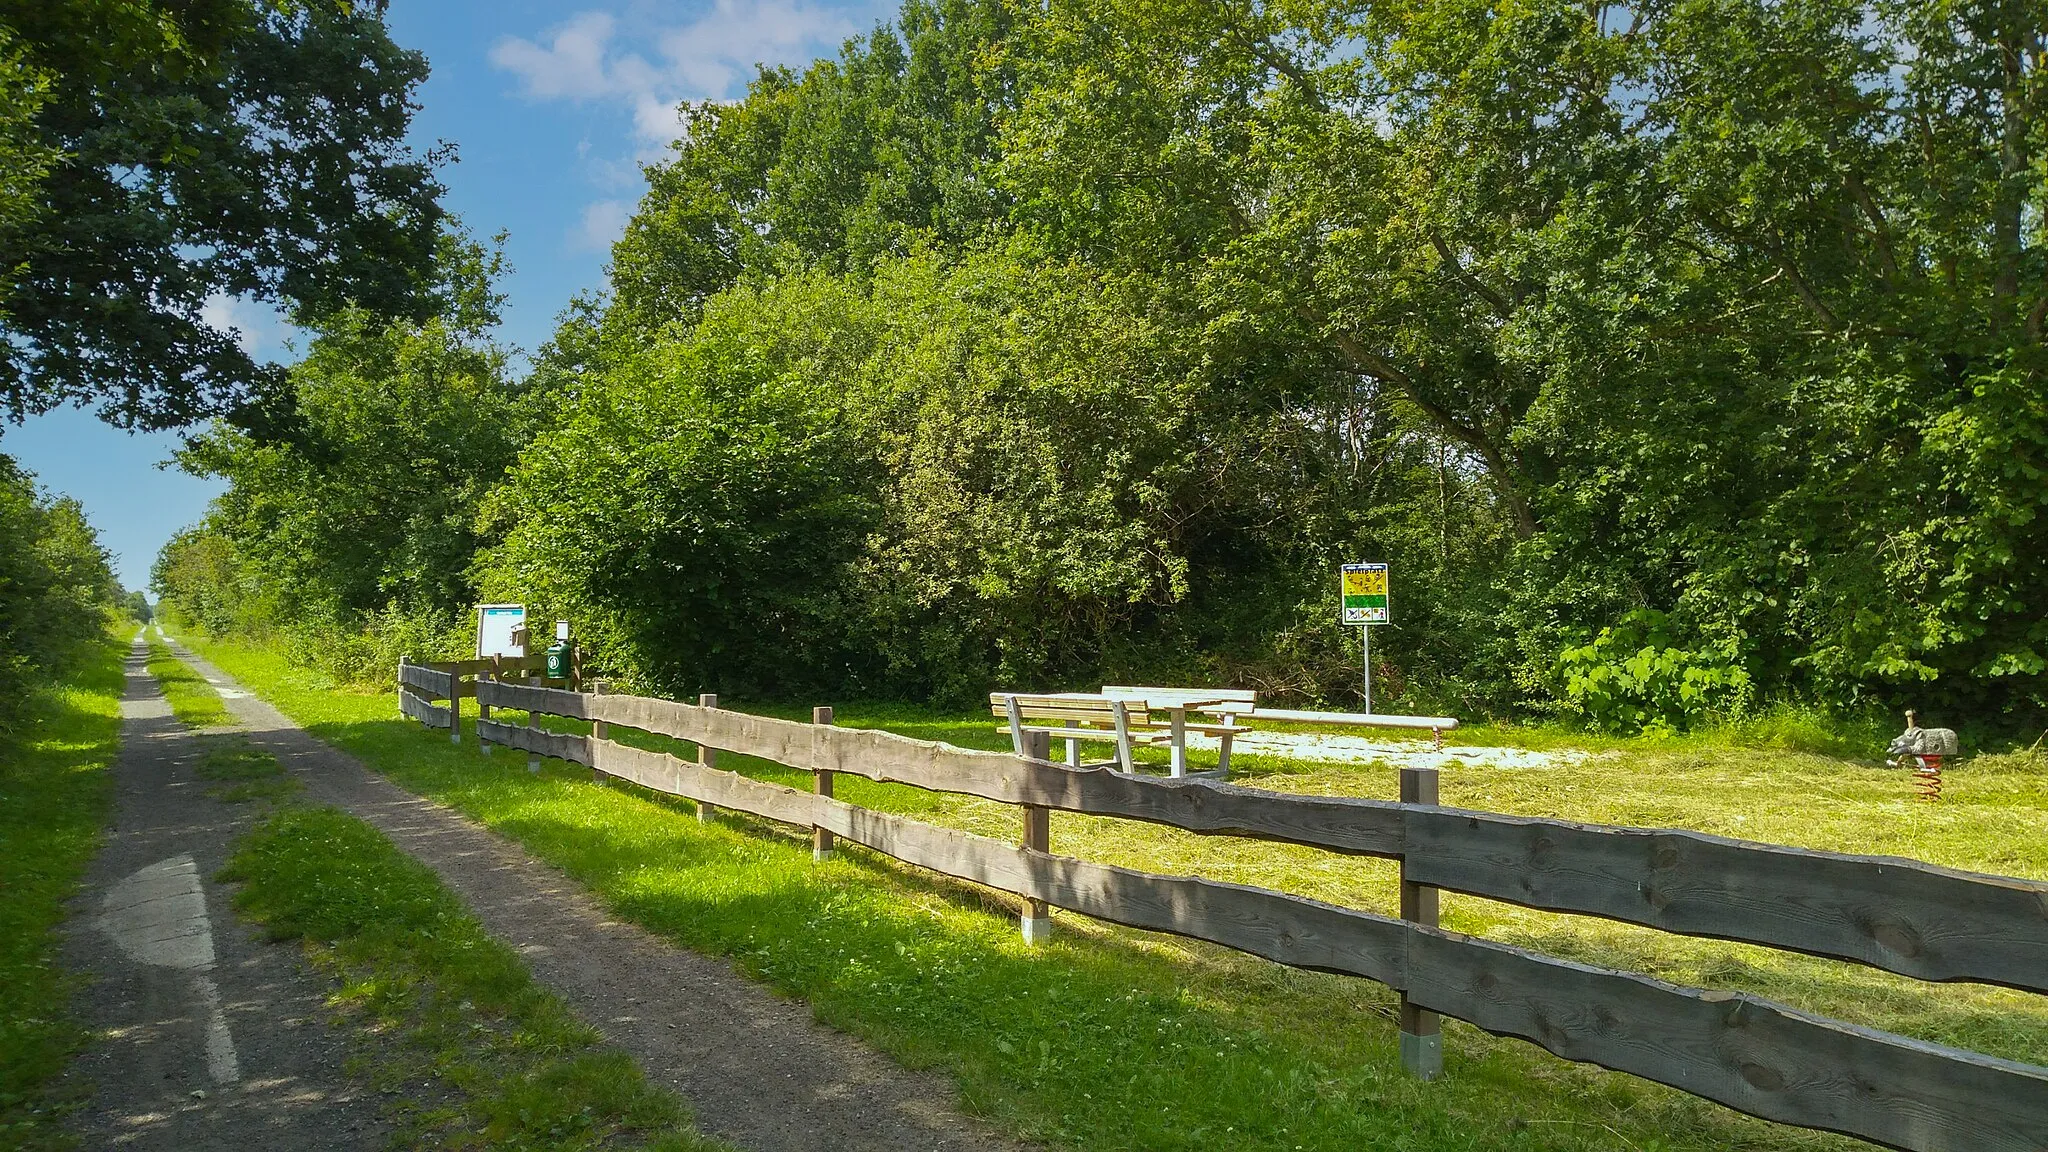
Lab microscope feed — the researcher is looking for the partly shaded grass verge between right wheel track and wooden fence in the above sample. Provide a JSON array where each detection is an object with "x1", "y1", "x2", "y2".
[{"x1": 272, "y1": 705, "x2": 1884, "y2": 1150}]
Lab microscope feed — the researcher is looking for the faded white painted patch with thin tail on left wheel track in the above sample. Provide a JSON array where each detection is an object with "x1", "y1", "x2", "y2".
[{"x1": 98, "y1": 855, "x2": 242, "y2": 1084}]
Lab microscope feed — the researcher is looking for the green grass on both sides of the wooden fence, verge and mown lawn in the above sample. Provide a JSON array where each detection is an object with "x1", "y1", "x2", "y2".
[{"x1": 188, "y1": 644, "x2": 2048, "y2": 1152}]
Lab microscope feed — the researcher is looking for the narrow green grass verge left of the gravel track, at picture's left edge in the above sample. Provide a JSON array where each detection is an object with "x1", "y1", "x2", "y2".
[{"x1": 0, "y1": 629, "x2": 127, "y2": 1150}]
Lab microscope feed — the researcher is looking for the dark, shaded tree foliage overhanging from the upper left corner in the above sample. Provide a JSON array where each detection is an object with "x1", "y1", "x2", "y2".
[{"x1": 0, "y1": 0, "x2": 440, "y2": 428}]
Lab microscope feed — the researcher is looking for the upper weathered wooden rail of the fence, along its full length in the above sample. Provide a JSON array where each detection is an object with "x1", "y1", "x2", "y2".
[{"x1": 479, "y1": 685, "x2": 2048, "y2": 992}]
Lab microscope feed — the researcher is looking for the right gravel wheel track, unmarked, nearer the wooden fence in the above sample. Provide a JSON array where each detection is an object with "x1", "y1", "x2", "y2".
[{"x1": 174, "y1": 635, "x2": 1016, "y2": 1152}]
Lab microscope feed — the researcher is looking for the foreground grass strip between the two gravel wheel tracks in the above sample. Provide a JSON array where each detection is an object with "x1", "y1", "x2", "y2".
[{"x1": 221, "y1": 799, "x2": 719, "y2": 1152}]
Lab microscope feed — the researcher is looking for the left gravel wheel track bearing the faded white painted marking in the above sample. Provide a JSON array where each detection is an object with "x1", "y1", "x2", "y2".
[{"x1": 61, "y1": 642, "x2": 387, "y2": 1152}]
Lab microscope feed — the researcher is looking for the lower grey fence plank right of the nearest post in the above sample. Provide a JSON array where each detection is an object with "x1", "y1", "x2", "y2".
[{"x1": 1407, "y1": 927, "x2": 2048, "y2": 1152}]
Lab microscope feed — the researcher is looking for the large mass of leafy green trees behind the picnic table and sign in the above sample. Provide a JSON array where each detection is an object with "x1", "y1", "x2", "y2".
[{"x1": 155, "y1": 0, "x2": 2048, "y2": 726}]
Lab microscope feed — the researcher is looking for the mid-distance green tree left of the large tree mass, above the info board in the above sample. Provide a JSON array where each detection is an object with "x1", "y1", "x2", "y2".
[{"x1": 174, "y1": 236, "x2": 524, "y2": 625}]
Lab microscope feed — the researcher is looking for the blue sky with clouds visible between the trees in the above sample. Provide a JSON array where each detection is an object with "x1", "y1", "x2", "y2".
[{"x1": 0, "y1": 0, "x2": 893, "y2": 588}]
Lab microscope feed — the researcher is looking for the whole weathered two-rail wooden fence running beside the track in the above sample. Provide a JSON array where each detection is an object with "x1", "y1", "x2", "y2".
[{"x1": 399, "y1": 666, "x2": 2048, "y2": 1152}]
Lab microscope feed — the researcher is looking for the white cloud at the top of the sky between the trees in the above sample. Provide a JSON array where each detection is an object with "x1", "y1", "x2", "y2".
[{"x1": 492, "y1": 0, "x2": 856, "y2": 147}]
